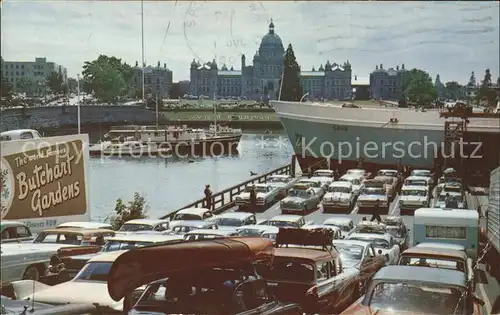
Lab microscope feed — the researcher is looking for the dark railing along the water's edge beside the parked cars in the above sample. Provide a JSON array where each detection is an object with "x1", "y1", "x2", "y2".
[{"x1": 160, "y1": 157, "x2": 295, "y2": 219}]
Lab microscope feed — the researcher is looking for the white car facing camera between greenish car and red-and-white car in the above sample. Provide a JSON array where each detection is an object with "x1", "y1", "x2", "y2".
[{"x1": 322, "y1": 181, "x2": 355, "y2": 212}]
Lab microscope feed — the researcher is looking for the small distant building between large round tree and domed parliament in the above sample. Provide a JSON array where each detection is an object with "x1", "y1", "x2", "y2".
[{"x1": 133, "y1": 61, "x2": 172, "y2": 98}]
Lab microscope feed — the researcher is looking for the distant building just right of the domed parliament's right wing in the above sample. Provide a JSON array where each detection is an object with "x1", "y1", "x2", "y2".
[{"x1": 370, "y1": 64, "x2": 406, "y2": 101}]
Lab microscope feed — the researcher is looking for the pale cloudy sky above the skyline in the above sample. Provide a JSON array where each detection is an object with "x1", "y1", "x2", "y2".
[{"x1": 1, "y1": 0, "x2": 500, "y2": 83}]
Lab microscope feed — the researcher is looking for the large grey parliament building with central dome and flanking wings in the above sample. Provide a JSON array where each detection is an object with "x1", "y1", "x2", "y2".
[{"x1": 189, "y1": 21, "x2": 352, "y2": 99}]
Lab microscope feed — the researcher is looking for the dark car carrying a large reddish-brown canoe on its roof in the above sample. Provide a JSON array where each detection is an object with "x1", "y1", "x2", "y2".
[{"x1": 108, "y1": 237, "x2": 301, "y2": 315}]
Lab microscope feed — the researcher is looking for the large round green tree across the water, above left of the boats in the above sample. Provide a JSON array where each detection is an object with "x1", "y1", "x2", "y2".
[{"x1": 82, "y1": 55, "x2": 135, "y2": 103}]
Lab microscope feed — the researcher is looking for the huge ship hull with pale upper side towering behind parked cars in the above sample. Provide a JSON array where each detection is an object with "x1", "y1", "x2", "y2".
[{"x1": 271, "y1": 101, "x2": 500, "y2": 175}]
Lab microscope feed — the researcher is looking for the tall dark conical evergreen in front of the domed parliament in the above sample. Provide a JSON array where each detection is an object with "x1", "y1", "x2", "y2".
[{"x1": 277, "y1": 44, "x2": 302, "y2": 102}]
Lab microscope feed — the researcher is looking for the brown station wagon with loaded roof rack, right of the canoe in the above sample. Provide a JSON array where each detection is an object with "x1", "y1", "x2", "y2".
[{"x1": 258, "y1": 229, "x2": 359, "y2": 314}]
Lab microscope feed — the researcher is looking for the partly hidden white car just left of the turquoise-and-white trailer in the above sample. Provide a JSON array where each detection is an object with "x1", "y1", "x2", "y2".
[{"x1": 347, "y1": 233, "x2": 400, "y2": 265}]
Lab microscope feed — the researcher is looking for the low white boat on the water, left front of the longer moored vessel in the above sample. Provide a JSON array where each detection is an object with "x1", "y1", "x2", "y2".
[{"x1": 89, "y1": 140, "x2": 172, "y2": 157}]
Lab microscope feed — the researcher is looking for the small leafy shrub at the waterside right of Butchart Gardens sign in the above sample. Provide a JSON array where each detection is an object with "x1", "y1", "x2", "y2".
[{"x1": 106, "y1": 192, "x2": 148, "y2": 230}]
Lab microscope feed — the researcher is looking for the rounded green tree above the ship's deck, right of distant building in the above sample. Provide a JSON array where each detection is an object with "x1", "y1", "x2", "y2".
[{"x1": 401, "y1": 69, "x2": 437, "y2": 105}]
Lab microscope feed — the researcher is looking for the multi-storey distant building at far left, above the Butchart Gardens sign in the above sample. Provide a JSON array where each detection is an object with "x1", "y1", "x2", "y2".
[{"x1": 1, "y1": 57, "x2": 68, "y2": 94}]
